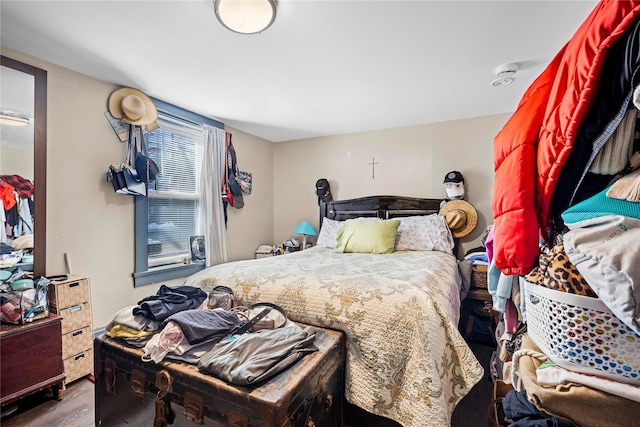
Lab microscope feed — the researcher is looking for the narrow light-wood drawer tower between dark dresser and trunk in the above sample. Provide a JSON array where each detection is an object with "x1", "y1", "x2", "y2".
[{"x1": 49, "y1": 274, "x2": 93, "y2": 383}]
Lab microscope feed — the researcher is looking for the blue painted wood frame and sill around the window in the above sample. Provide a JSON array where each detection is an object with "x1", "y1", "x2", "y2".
[{"x1": 132, "y1": 97, "x2": 224, "y2": 287}]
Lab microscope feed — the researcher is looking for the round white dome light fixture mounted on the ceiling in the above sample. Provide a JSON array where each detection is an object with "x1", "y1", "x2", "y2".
[{"x1": 213, "y1": 0, "x2": 278, "y2": 34}]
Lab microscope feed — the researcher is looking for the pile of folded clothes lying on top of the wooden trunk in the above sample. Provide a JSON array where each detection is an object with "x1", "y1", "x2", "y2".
[{"x1": 106, "y1": 285, "x2": 318, "y2": 385}]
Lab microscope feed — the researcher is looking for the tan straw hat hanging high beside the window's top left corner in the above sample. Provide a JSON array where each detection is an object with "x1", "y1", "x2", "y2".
[{"x1": 109, "y1": 87, "x2": 158, "y2": 125}]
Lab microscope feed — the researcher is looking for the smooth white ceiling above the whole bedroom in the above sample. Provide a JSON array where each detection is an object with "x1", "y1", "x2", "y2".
[{"x1": 0, "y1": 0, "x2": 597, "y2": 142}]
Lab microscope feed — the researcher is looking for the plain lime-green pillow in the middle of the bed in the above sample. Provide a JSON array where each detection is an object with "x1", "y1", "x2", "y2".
[{"x1": 336, "y1": 219, "x2": 400, "y2": 254}]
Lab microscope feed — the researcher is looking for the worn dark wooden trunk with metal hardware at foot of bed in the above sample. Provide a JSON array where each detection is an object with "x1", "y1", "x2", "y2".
[{"x1": 94, "y1": 328, "x2": 345, "y2": 427}]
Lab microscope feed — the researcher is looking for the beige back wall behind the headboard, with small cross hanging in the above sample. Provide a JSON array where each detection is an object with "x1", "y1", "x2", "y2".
[{"x1": 273, "y1": 114, "x2": 509, "y2": 260}]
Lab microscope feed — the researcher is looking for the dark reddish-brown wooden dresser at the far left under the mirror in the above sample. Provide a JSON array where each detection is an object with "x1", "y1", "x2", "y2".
[{"x1": 0, "y1": 315, "x2": 65, "y2": 405}]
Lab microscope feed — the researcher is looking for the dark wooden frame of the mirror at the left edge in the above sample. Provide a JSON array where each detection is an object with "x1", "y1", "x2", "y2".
[{"x1": 0, "y1": 55, "x2": 47, "y2": 277}]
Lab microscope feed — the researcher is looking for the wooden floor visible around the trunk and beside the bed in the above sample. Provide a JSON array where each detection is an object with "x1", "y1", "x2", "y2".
[{"x1": 0, "y1": 343, "x2": 492, "y2": 427}]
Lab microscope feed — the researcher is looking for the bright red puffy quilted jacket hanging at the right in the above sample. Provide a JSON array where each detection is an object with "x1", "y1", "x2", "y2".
[{"x1": 492, "y1": 0, "x2": 640, "y2": 275}]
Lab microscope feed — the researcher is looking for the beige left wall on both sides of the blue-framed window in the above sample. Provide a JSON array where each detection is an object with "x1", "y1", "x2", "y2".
[{"x1": 2, "y1": 48, "x2": 273, "y2": 328}]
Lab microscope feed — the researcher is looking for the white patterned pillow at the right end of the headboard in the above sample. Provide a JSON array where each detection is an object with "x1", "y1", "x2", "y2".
[{"x1": 396, "y1": 214, "x2": 454, "y2": 253}]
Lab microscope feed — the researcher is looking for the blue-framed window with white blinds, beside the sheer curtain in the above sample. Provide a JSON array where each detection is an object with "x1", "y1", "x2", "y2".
[{"x1": 133, "y1": 99, "x2": 224, "y2": 286}]
